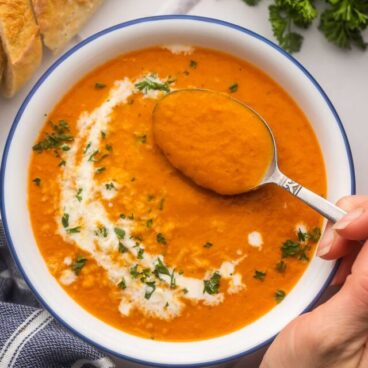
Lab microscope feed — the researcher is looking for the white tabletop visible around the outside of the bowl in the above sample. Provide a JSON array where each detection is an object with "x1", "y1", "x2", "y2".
[{"x1": 0, "y1": 0, "x2": 368, "y2": 368}]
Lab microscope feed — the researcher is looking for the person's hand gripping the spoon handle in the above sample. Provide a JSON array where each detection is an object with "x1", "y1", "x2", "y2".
[{"x1": 261, "y1": 196, "x2": 368, "y2": 368}]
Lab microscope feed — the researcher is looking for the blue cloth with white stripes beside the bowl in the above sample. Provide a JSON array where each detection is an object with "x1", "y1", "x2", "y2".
[{"x1": 0, "y1": 221, "x2": 115, "y2": 368}]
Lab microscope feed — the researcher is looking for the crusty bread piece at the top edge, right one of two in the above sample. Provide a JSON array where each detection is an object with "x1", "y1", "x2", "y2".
[{"x1": 32, "y1": 0, "x2": 103, "y2": 52}]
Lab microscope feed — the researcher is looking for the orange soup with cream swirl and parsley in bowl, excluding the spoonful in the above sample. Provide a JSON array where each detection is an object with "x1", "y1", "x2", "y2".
[{"x1": 29, "y1": 47, "x2": 326, "y2": 341}]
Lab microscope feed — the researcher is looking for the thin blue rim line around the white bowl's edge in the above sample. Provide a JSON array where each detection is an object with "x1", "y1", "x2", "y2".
[{"x1": 0, "y1": 15, "x2": 356, "y2": 368}]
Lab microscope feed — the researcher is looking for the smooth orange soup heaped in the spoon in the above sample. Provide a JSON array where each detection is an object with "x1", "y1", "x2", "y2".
[{"x1": 153, "y1": 89, "x2": 273, "y2": 195}]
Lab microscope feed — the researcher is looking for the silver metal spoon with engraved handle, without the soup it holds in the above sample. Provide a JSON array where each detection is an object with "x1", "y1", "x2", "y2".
[{"x1": 153, "y1": 89, "x2": 346, "y2": 223}]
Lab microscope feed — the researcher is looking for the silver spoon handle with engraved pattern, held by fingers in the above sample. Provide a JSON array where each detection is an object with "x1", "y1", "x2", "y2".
[{"x1": 275, "y1": 173, "x2": 346, "y2": 223}]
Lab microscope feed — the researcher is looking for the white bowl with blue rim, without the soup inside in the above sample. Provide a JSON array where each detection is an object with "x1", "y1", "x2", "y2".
[{"x1": 1, "y1": 16, "x2": 355, "y2": 367}]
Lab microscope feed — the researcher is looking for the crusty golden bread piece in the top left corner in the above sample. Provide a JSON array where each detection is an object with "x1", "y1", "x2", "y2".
[{"x1": 0, "y1": 0, "x2": 42, "y2": 97}]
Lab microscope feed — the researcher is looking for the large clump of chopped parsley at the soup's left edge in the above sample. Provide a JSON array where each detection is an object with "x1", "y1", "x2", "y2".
[{"x1": 32, "y1": 120, "x2": 74, "y2": 153}]
